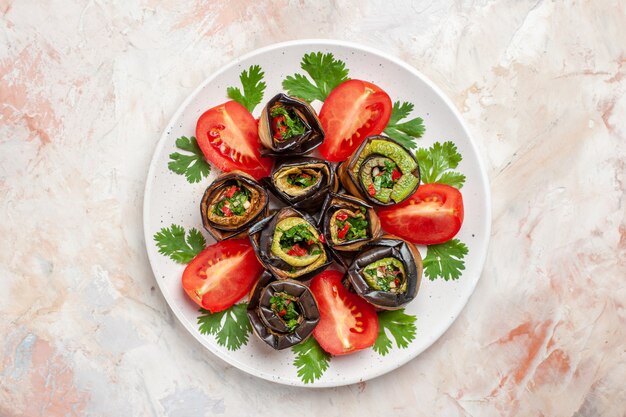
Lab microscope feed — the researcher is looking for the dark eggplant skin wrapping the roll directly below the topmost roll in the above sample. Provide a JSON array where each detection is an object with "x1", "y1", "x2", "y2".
[{"x1": 261, "y1": 156, "x2": 339, "y2": 213}]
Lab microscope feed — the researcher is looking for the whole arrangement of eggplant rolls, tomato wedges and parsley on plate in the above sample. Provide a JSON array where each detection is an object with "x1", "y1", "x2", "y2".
[{"x1": 154, "y1": 52, "x2": 467, "y2": 383}]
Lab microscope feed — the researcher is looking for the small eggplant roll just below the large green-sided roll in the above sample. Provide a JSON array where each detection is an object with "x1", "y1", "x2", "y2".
[{"x1": 320, "y1": 193, "x2": 382, "y2": 252}]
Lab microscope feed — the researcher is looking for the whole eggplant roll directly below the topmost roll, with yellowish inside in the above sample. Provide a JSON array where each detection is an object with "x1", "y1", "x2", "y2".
[{"x1": 263, "y1": 157, "x2": 339, "y2": 211}]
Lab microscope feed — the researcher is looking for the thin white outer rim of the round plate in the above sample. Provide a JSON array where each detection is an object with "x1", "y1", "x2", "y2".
[{"x1": 142, "y1": 38, "x2": 492, "y2": 388}]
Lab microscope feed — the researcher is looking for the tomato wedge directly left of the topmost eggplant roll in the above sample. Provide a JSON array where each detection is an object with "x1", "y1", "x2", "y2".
[{"x1": 196, "y1": 101, "x2": 272, "y2": 180}]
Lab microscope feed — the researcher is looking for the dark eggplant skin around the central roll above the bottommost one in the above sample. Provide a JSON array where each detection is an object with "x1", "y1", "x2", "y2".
[{"x1": 248, "y1": 207, "x2": 333, "y2": 281}]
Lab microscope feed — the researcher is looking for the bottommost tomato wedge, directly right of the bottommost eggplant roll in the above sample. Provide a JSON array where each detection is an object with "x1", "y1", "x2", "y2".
[{"x1": 310, "y1": 271, "x2": 378, "y2": 355}]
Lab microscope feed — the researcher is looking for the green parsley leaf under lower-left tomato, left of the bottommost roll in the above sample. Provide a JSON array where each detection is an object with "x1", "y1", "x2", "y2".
[{"x1": 198, "y1": 303, "x2": 252, "y2": 350}]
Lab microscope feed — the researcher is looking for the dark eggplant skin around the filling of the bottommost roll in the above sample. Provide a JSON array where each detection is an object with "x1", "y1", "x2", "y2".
[{"x1": 247, "y1": 271, "x2": 320, "y2": 350}]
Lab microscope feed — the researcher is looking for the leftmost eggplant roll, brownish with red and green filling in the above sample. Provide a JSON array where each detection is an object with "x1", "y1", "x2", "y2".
[{"x1": 200, "y1": 172, "x2": 269, "y2": 240}]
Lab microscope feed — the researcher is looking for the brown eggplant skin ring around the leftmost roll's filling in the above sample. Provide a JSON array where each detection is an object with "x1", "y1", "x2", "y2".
[{"x1": 200, "y1": 171, "x2": 269, "y2": 241}]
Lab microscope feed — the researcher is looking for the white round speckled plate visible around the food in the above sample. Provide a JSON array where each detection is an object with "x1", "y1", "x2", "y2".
[{"x1": 144, "y1": 40, "x2": 491, "y2": 387}]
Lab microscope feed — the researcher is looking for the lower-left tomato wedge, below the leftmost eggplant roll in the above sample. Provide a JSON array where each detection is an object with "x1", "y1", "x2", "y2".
[{"x1": 183, "y1": 239, "x2": 263, "y2": 313}]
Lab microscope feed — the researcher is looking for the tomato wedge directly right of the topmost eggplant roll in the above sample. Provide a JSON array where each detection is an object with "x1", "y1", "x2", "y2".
[{"x1": 318, "y1": 80, "x2": 391, "y2": 162}]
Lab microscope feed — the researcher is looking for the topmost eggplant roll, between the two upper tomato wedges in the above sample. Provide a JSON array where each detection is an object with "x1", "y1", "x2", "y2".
[{"x1": 259, "y1": 94, "x2": 324, "y2": 156}]
